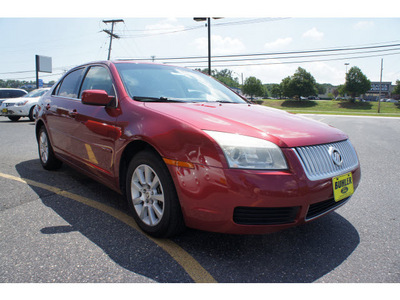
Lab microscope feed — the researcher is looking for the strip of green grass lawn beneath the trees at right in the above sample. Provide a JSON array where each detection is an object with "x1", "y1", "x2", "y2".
[{"x1": 262, "y1": 99, "x2": 400, "y2": 117}]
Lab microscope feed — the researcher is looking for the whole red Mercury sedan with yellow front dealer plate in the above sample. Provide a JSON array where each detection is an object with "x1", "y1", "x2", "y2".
[{"x1": 36, "y1": 61, "x2": 361, "y2": 237}]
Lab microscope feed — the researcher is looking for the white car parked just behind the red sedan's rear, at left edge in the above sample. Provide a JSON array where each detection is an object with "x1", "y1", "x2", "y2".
[{"x1": 0, "y1": 88, "x2": 50, "y2": 122}]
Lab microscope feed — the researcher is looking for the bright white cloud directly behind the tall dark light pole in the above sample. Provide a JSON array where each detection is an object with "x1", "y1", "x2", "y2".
[{"x1": 194, "y1": 35, "x2": 246, "y2": 55}]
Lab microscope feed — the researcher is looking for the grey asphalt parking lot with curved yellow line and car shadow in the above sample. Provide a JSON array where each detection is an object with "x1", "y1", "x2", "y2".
[{"x1": 0, "y1": 115, "x2": 400, "y2": 283}]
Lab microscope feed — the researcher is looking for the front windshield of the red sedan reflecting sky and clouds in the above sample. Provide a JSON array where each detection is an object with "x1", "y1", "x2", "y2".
[{"x1": 116, "y1": 63, "x2": 246, "y2": 103}]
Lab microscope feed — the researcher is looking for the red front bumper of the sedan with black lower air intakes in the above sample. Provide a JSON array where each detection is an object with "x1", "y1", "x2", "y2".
[{"x1": 168, "y1": 150, "x2": 361, "y2": 234}]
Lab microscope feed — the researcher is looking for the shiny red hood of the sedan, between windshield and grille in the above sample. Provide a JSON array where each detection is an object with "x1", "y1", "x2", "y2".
[{"x1": 145, "y1": 102, "x2": 348, "y2": 147}]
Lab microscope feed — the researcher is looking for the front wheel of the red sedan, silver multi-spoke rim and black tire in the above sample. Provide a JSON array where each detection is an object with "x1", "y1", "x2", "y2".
[{"x1": 126, "y1": 151, "x2": 184, "y2": 237}]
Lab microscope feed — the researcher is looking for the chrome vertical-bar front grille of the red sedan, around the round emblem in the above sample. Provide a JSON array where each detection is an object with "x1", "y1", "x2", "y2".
[{"x1": 295, "y1": 140, "x2": 358, "y2": 180}]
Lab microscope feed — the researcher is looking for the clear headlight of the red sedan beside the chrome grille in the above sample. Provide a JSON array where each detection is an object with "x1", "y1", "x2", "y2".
[{"x1": 204, "y1": 130, "x2": 288, "y2": 170}]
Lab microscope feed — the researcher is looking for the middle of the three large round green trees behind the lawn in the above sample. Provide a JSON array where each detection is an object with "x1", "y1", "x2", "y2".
[{"x1": 281, "y1": 67, "x2": 318, "y2": 97}]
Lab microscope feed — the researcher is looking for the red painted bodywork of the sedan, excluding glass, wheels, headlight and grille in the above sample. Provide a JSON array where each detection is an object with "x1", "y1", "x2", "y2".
[{"x1": 36, "y1": 62, "x2": 361, "y2": 234}]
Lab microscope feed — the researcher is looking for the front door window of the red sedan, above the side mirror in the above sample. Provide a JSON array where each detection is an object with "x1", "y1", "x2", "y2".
[{"x1": 81, "y1": 66, "x2": 115, "y2": 96}]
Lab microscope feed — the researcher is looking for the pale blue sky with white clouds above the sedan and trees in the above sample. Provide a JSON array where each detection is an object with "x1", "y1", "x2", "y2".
[{"x1": 0, "y1": 0, "x2": 400, "y2": 85}]
